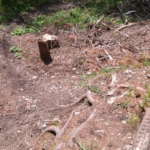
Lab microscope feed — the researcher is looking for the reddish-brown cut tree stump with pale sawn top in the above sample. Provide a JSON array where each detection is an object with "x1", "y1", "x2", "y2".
[{"x1": 38, "y1": 34, "x2": 59, "y2": 64}]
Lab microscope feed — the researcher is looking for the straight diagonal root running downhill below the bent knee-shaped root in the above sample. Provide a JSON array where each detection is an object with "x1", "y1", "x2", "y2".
[{"x1": 67, "y1": 109, "x2": 97, "y2": 147}]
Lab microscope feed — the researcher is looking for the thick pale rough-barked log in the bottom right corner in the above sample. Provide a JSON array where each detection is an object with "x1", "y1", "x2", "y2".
[{"x1": 133, "y1": 108, "x2": 150, "y2": 150}]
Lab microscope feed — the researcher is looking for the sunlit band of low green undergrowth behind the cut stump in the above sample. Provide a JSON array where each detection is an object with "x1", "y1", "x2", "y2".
[{"x1": 11, "y1": 8, "x2": 98, "y2": 36}]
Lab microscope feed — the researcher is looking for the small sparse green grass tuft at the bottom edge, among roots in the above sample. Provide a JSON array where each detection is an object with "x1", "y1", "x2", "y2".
[{"x1": 77, "y1": 140, "x2": 97, "y2": 150}]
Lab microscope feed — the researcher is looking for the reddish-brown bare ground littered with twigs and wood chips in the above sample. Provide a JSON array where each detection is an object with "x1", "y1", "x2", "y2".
[{"x1": 0, "y1": 1, "x2": 150, "y2": 150}]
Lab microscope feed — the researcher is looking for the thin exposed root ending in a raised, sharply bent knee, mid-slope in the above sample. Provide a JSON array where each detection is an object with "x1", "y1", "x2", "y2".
[{"x1": 57, "y1": 91, "x2": 95, "y2": 108}]
